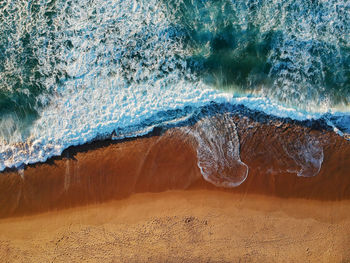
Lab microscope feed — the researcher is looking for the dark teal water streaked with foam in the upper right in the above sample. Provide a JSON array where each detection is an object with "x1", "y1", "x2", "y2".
[{"x1": 165, "y1": 0, "x2": 350, "y2": 108}]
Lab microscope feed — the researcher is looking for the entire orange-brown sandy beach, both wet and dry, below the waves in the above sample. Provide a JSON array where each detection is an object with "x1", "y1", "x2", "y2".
[{"x1": 0, "y1": 117, "x2": 350, "y2": 262}]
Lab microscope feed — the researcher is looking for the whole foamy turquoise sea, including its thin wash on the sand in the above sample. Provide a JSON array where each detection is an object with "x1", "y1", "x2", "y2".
[{"x1": 0, "y1": 0, "x2": 350, "y2": 175}]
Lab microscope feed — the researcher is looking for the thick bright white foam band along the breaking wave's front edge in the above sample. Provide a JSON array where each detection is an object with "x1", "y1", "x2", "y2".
[{"x1": 0, "y1": 75, "x2": 344, "y2": 172}]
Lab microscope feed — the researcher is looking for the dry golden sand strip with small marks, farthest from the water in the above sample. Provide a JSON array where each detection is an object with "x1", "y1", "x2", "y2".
[{"x1": 0, "y1": 190, "x2": 350, "y2": 262}]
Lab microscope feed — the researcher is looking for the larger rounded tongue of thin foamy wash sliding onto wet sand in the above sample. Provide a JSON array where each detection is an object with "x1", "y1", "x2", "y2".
[{"x1": 180, "y1": 114, "x2": 249, "y2": 187}]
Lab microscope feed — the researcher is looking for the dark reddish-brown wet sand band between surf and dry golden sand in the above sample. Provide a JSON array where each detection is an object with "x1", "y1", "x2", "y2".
[{"x1": 0, "y1": 115, "x2": 350, "y2": 218}]
